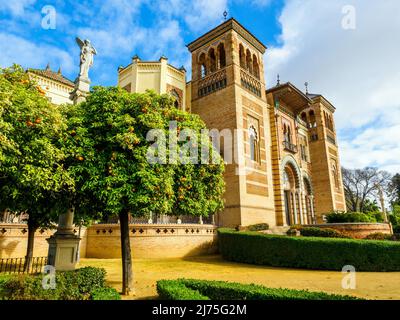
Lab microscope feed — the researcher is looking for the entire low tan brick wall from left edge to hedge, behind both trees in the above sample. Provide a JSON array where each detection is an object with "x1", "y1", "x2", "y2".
[{"x1": 0, "y1": 224, "x2": 217, "y2": 259}]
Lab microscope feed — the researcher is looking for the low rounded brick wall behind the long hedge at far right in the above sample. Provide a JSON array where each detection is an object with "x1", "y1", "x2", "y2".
[{"x1": 312, "y1": 222, "x2": 393, "y2": 239}]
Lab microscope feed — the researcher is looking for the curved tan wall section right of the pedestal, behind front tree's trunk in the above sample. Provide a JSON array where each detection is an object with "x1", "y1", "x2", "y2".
[{"x1": 86, "y1": 224, "x2": 217, "y2": 259}]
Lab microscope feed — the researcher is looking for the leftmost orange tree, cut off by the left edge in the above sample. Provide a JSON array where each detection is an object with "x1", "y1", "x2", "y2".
[{"x1": 0, "y1": 65, "x2": 74, "y2": 268}]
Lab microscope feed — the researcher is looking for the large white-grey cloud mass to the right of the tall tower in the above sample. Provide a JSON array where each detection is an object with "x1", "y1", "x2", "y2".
[{"x1": 266, "y1": 0, "x2": 400, "y2": 171}]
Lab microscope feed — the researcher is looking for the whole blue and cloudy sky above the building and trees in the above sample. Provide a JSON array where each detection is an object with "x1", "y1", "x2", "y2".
[{"x1": 0, "y1": 0, "x2": 400, "y2": 173}]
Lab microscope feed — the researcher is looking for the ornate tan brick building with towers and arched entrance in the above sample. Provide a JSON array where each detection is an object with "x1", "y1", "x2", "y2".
[{"x1": 119, "y1": 18, "x2": 346, "y2": 226}]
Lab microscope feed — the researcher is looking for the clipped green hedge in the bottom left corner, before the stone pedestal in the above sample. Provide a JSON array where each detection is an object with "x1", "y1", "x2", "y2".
[{"x1": 0, "y1": 267, "x2": 120, "y2": 300}]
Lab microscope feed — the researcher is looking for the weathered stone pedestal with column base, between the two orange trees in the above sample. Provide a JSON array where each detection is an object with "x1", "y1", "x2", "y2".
[{"x1": 47, "y1": 208, "x2": 81, "y2": 271}]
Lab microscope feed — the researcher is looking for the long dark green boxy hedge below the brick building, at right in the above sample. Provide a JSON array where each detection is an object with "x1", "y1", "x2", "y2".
[{"x1": 218, "y1": 228, "x2": 400, "y2": 271}]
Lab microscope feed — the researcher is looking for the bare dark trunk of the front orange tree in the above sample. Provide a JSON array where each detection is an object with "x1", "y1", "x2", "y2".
[{"x1": 119, "y1": 211, "x2": 133, "y2": 295}]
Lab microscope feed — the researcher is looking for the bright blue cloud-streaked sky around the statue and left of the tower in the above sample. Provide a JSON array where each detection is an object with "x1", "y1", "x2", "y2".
[{"x1": 0, "y1": 0, "x2": 283, "y2": 85}]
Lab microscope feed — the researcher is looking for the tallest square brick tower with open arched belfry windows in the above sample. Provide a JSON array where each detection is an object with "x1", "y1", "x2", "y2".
[{"x1": 188, "y1": 18, "x2": 275, "y2": 226}]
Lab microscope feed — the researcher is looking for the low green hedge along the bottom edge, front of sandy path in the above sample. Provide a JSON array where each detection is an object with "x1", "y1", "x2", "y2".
[{"x1": 157, "y1": 279, "x2": 358, "y2": 300}]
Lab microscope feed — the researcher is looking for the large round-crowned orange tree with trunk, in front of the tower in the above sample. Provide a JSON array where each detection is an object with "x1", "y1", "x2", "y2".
[{"x1": 64, "y1": 87, "x2": 224, "y2": 294}]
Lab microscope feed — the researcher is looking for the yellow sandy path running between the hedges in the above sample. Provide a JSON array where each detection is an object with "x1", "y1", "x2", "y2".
[{"x1": 80, "y1": 255, "x2": 400, "y2": 300}]
